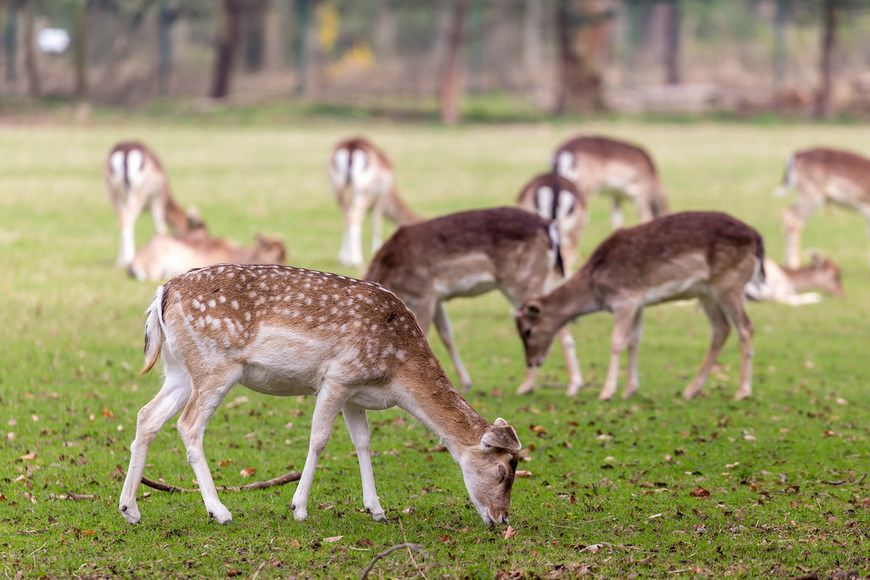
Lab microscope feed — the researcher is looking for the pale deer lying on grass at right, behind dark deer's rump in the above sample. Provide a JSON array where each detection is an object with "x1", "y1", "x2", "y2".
[{"x1": 746, "y1": 253, "x2": 844, "y2": 306}]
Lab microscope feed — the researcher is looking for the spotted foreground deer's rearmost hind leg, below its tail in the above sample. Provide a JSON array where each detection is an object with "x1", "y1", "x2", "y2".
[{"x1": 118, "y1": 350, "x2": 191, "y2": 524}]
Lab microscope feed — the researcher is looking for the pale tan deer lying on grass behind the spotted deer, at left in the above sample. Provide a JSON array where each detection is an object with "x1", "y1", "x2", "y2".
[{"x1": 129, "y1": 233, "x2": 287, "y2": 281}]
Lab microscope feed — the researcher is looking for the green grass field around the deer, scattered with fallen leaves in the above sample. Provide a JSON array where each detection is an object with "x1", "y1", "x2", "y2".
[{"x1": 0, "y1": 115, "x2": 870, "y2": 578}]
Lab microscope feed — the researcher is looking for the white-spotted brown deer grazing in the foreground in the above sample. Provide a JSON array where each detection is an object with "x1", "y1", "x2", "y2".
[{"x1": 119, "y1": 265, "x2": 521, "y2": 524}]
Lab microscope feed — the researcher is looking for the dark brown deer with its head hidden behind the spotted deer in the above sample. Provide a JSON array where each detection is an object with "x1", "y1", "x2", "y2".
[{"x1": 365, "y1": 207, "x2": 583, "y2": 395}]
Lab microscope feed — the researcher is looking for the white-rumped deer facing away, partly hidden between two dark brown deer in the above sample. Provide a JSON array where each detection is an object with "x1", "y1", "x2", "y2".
[{"x1": 517, "y1": 173, "x2": 589, "y2": 272}]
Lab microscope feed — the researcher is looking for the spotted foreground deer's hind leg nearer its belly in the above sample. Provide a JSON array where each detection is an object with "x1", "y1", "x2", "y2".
[{"x1": 178, "y1": 368, "x2": 239, "y2": 524}]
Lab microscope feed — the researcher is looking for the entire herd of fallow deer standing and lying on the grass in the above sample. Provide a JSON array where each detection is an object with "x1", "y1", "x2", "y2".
[{"x1": 103, "y1": 135, "x2": 870, "y2": 524}]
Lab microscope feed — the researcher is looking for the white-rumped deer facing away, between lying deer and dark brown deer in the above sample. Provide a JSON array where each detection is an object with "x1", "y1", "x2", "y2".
[{"x1": 329, "y1": 137, "x2": 419, "y2": 268}]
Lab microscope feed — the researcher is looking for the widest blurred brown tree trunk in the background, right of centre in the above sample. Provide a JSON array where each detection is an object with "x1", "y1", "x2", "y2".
[{"x1": 554, "y1": 0, "x2": 615, "y2": 115}]
